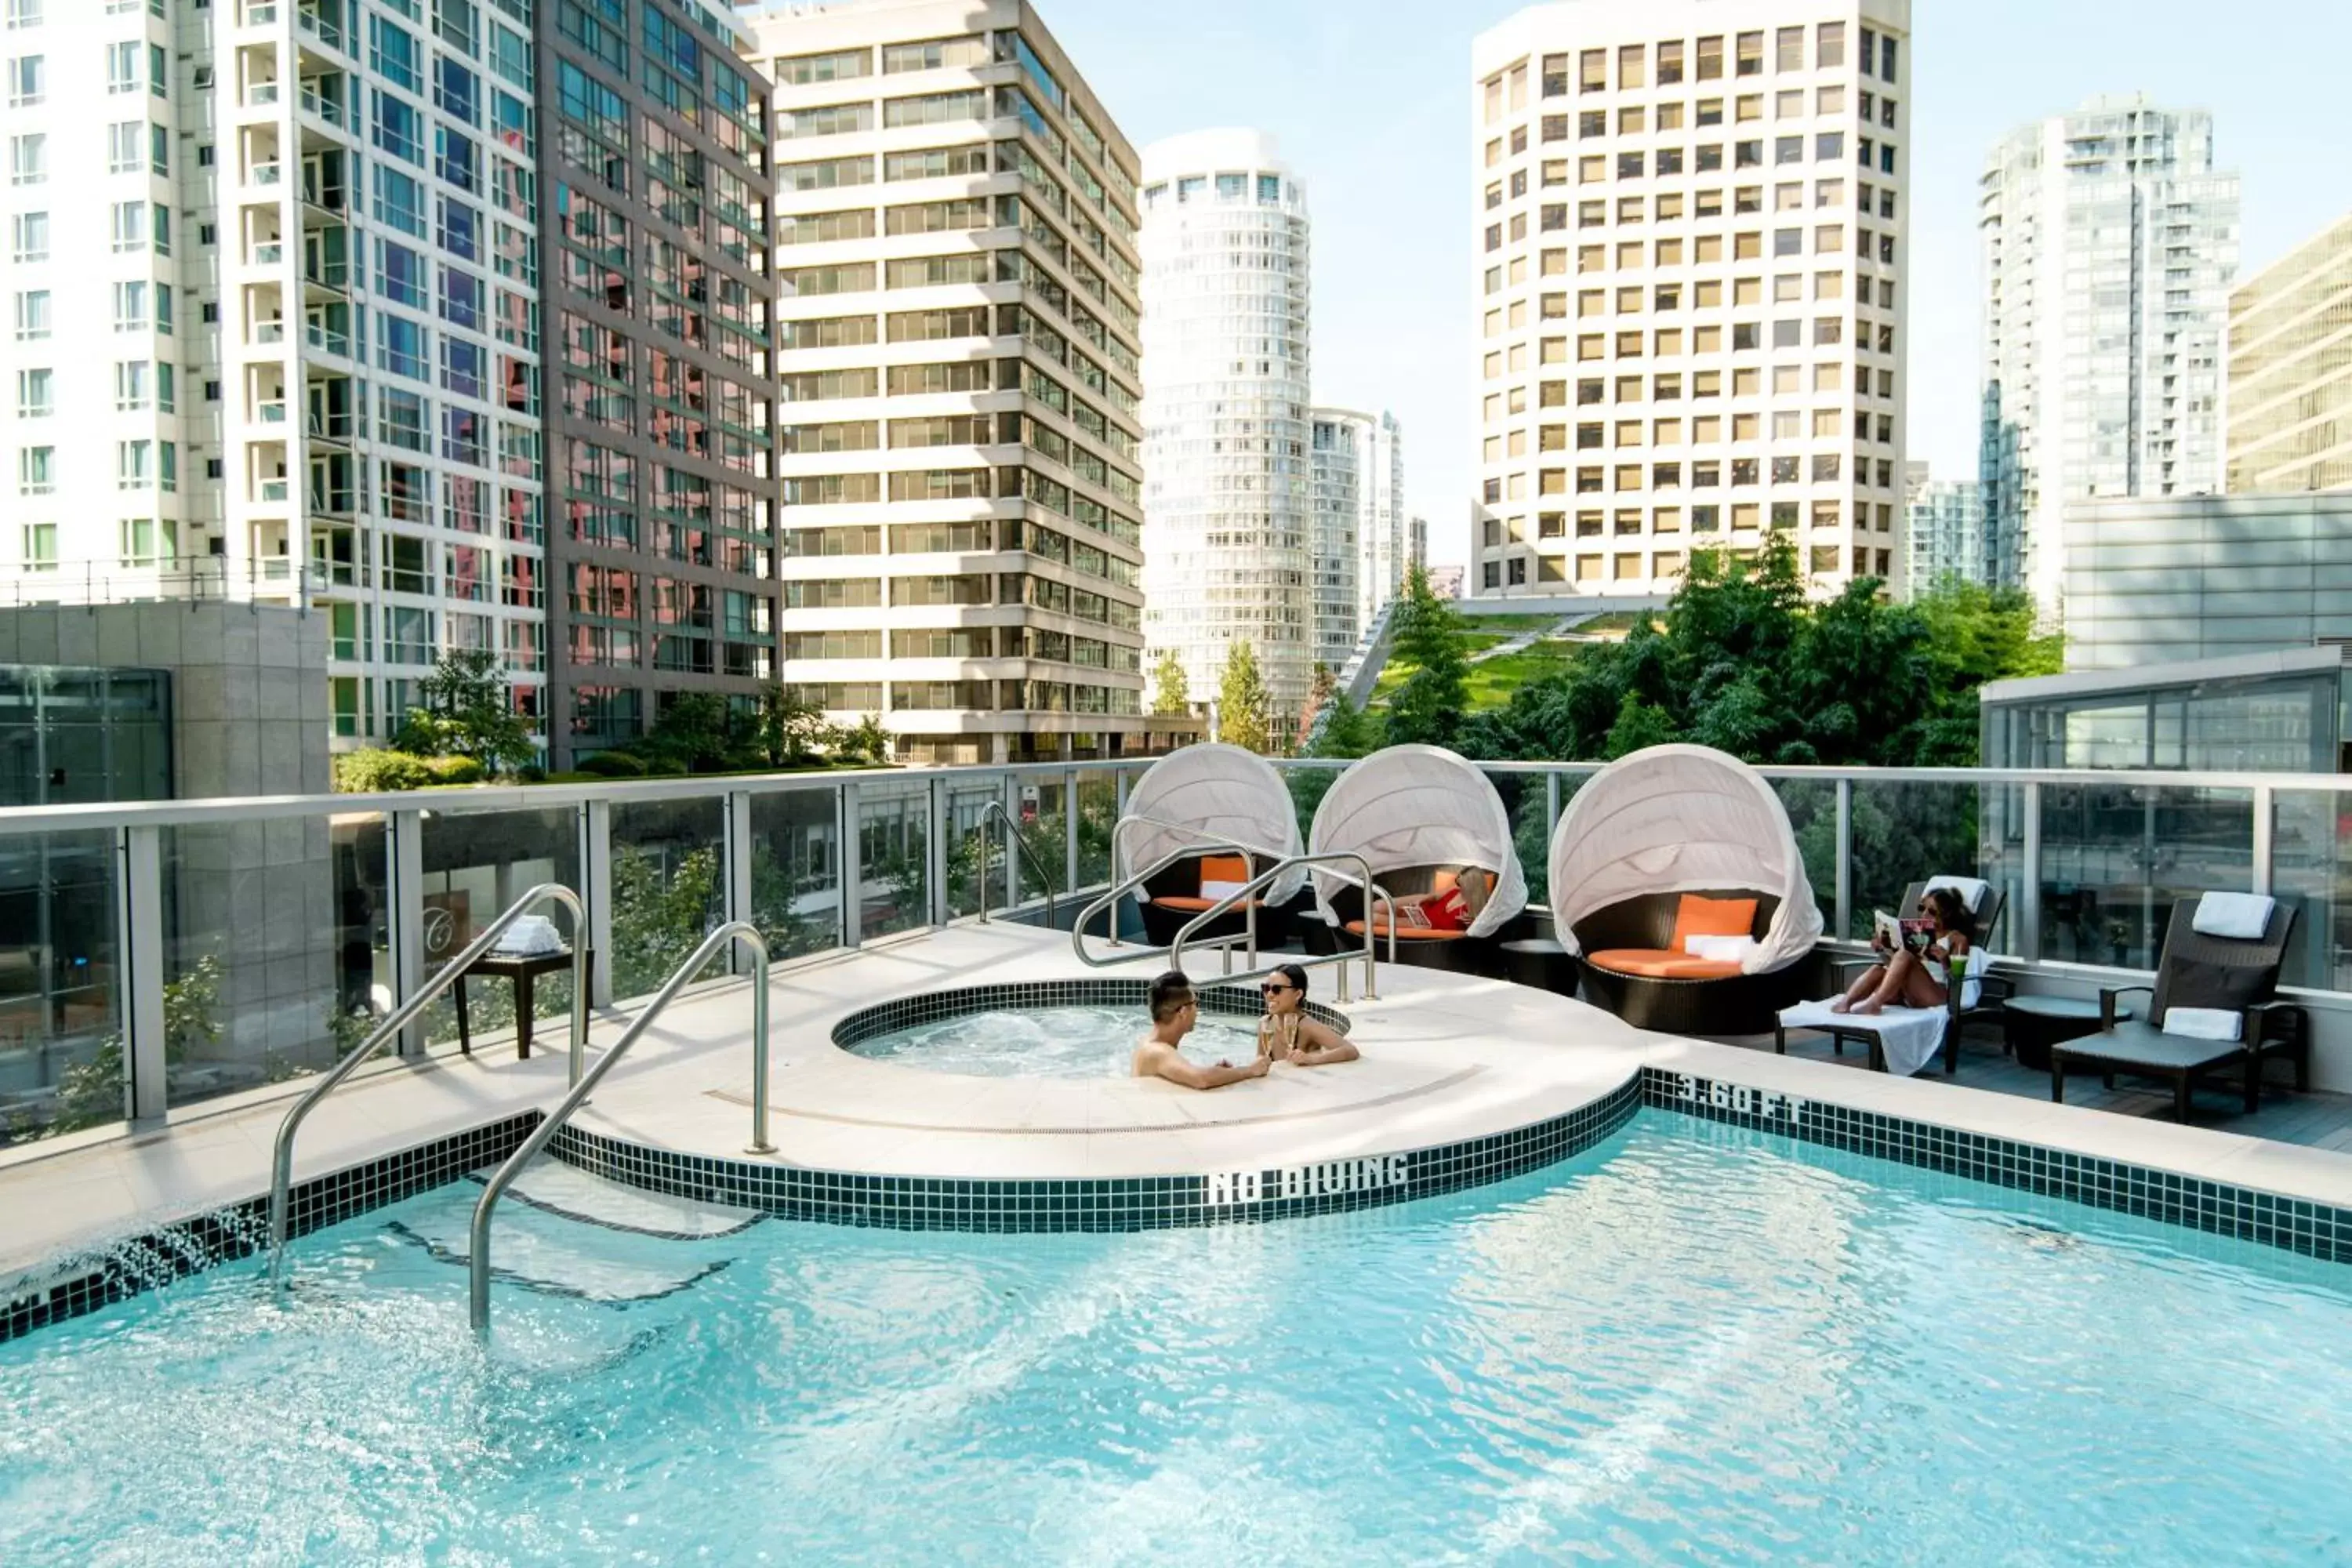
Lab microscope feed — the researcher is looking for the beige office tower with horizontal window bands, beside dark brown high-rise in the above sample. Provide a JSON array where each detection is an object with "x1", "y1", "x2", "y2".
[{"x1": 750, "y1": 0, "x2": 1152, "y2": 762}]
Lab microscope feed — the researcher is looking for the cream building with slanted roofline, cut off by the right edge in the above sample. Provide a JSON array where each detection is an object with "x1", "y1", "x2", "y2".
[{"x1": 2225, "y1": 216, "x2": 2352, "y2": 494}]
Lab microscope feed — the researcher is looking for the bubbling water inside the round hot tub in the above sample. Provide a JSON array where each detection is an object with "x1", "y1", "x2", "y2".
[{"x1": 844, "y1": 1006, "x2": 1258, "y2": 1079}]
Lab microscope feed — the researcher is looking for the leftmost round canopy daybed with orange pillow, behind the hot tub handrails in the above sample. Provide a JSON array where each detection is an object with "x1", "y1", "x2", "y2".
[{"x1": 1112, "y1": 741, "x2": 1305, "y2": 947}]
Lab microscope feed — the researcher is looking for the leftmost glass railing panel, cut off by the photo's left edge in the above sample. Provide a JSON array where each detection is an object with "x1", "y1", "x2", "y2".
[{"x1": 0, "y1": 829, "x2": 125, "y2": 1145}]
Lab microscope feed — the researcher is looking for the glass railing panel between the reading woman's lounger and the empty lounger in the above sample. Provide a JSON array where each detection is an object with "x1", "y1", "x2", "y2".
[{"x1": 2039, "y1": 783, "x2": 2253, "y2": 968}]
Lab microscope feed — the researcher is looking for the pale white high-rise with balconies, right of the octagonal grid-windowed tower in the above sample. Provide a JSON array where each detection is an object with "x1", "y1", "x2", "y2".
[{"x1": 1978, "y1": 96, "x2": 2237, "y2": 616}]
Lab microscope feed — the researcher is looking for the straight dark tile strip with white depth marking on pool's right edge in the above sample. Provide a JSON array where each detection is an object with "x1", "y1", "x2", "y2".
[{"x1": 1639, "y1": 1067, "x2": 2352, "y2": 1262}]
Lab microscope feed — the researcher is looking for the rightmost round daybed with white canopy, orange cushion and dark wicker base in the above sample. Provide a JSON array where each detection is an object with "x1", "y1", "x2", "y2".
[{"x1": 1550, "y1": 746, "x2": 1820, "y2": 1034}]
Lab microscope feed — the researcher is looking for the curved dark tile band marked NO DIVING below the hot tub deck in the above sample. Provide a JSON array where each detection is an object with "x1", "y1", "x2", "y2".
[{"x1": 550, "y1": 1079, "x2": 1642, "y2": 1232}]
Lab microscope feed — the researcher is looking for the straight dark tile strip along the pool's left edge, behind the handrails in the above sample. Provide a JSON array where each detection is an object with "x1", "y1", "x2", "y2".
[{"x1": 0, "y1": 1109, "x2": 539, "y2": 1340}]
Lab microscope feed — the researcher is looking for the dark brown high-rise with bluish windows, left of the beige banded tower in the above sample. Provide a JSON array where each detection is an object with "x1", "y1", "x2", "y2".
[{"x1": 541, "y1": 0, "x2": 779, "y2": 767}]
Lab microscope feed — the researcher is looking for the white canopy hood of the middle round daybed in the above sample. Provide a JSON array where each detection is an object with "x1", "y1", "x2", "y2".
[{"x1": 1308, "y1": 746, "x2": 1526, "y2": 935}]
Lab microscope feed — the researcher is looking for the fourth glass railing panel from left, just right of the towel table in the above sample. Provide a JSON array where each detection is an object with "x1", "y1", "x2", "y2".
[{"x1": 612, "y1": 794, "x2": 727, "y2": 1001}]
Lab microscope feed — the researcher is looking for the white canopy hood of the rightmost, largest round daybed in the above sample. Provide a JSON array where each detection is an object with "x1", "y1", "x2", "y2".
[{"x1": 1550, "y1": 746, "x2": 1820, "y2": 973}]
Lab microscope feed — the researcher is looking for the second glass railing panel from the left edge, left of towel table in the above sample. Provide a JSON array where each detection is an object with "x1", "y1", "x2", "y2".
[{"x1": 162, "y1": 811, "x2": 390, "y2": 1109}]
